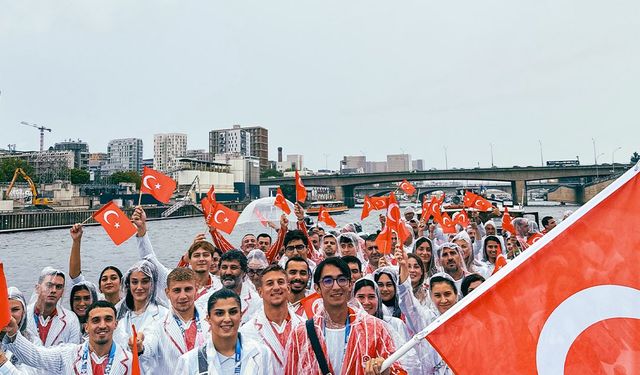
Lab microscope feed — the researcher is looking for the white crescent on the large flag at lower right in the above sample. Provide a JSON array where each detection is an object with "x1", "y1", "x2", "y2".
[{"x1": 536, "y1": 285, "x2": 640, "y2": 375}]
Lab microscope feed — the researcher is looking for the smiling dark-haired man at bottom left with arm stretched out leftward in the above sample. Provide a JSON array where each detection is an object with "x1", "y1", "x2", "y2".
[{"x1": 6, "y1": 301, "x2": 132, "y2": 375}]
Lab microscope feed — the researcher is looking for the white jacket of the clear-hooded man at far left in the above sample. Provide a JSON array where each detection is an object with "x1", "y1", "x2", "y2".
[{"x1": 27, "y1": 303, "x2": 82, "y2": 347}]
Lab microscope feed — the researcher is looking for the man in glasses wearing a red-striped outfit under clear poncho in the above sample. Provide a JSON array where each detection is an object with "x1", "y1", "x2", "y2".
[{"x1": 284, "y1": 257, "x2": 406, "y2": 375}]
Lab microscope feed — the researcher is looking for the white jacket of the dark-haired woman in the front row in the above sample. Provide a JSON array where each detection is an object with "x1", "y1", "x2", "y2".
[{"x1": 175, "y1": 337, "x2": 280, "y2": 375}]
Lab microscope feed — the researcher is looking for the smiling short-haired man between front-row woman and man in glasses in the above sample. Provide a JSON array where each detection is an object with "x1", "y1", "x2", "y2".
[{"x1": 240, "y1": 264, "x2": 303, "y2": 374}]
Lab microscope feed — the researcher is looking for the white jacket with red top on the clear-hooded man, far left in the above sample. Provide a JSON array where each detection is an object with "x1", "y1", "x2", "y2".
[{"x1": 26, "y1": 304, "x2": 82, "y2": 347}]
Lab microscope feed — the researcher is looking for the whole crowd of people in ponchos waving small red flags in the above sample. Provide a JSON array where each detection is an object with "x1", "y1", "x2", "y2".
[{"x1": 0, "y1": 204, "x2": 556, "y2": 375}]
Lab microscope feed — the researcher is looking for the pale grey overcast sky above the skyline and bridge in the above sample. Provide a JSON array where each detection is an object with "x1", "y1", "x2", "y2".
[{"x1": 0, "y1": 0, "x2": 640, "y2": 169}]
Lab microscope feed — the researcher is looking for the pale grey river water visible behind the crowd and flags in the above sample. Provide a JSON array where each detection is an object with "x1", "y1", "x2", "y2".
[{"x1": 0, "y1": 206, "x2": 577, "y2": 305}]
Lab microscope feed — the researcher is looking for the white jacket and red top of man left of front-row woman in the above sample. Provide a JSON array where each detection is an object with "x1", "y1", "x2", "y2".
[{"x1": 140, "y1": 311, "x2": 211, "y2": 375}]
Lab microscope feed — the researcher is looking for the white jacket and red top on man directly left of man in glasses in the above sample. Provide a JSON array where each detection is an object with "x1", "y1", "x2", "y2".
[{"x1": 240, "y1": 309, "x2": 304, "y2": 374}]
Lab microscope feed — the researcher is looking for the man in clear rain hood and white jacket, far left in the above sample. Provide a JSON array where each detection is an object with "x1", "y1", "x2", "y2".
[{"x1": 27, "y1": 267, "x2": 81, "y2": 347}]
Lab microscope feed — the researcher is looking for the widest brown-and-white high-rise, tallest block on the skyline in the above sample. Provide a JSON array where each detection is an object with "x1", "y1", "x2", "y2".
[{"x1": 209, "y1": 125, "x2": 269, "y2": 170}]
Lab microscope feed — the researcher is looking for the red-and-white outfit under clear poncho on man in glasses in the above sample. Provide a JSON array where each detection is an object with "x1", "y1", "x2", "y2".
[{"x1": 284, "y1": 307, "x2": 406, "y2": 375}]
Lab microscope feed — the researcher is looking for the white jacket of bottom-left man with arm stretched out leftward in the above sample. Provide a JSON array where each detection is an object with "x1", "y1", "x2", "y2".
[{"x1": 3, "y1": 333, "x2": 132, "y2": 375}]
